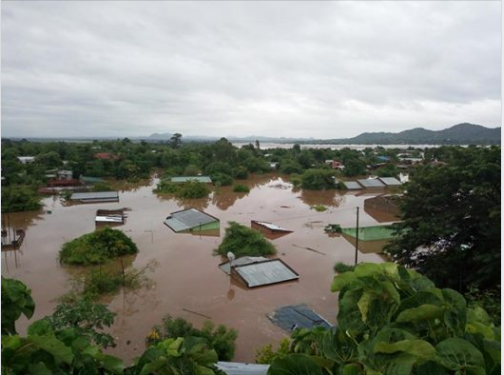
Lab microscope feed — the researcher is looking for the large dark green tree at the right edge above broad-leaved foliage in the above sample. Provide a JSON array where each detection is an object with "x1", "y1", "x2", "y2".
[{"x1": 388, "y1": 147, "x2": 501, "y2": 292}]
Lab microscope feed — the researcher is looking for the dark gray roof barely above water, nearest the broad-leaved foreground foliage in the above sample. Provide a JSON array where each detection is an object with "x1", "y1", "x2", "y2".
[{"x1": 268, "y1": 304, "x2": 332, "y2": 332}]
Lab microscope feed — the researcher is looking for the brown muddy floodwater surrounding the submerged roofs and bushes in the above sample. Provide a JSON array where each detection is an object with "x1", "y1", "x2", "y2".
[{"x1": 2, "y1": 175, "x2": 392, "y2": 364}]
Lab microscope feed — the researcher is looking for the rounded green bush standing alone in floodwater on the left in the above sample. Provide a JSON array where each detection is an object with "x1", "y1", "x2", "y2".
[{"x1": 60, "y1": 228, "x2": 138, "y2": 265}]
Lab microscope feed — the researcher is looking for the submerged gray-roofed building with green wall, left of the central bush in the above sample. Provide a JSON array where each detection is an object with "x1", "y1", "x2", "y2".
[{"x1": 164, "y1": 208, "x2": 220, "y2": 233}]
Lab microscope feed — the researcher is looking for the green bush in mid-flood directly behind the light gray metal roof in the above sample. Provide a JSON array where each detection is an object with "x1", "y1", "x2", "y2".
[{"x1": 215, "y1": 221, "x2": 276, "y2": 258}]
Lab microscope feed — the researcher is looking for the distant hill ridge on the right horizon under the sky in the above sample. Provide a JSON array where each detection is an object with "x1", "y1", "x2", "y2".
[{"x1": 324, "y1": 123, "x2": 501, "y2": 145}]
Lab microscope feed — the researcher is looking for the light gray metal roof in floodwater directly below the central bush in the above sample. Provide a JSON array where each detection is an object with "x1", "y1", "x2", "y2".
[{"x1": 233, "y1": 259, "x2": 299, "y2": 288}]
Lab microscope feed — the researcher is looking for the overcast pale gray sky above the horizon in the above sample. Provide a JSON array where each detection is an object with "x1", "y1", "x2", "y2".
[{"x1": 1, "y1": 1, "x2": 501, "y2": 138}]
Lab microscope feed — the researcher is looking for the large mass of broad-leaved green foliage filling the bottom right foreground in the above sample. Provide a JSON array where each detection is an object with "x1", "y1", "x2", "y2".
[{"x1": 268, "y1": 263, "x2": 501, "y2": 375}]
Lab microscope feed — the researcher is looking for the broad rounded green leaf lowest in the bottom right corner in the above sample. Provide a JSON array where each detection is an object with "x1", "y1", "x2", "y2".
[{"x1": 436, "y1": 337, "x2": 486, "y2": 375}]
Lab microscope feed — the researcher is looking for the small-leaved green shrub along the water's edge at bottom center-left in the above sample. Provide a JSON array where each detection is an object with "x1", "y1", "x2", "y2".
[{"x1": 146, "y1": 315, "x2": 238, "y2": 361}]
